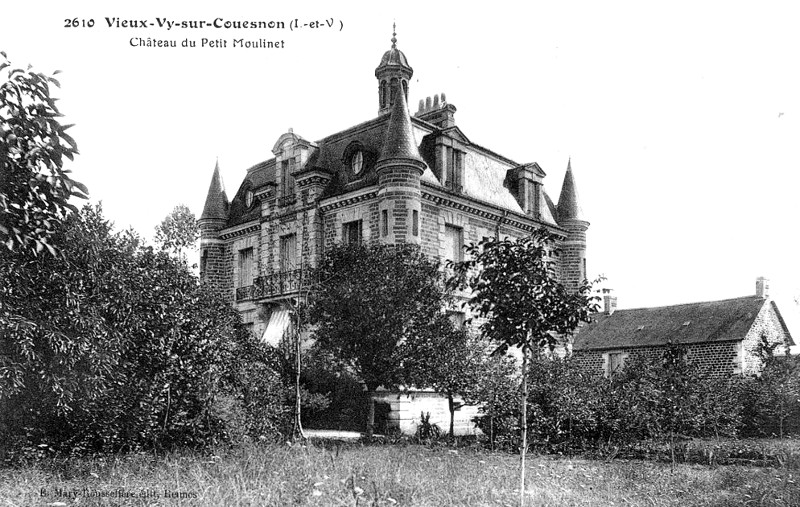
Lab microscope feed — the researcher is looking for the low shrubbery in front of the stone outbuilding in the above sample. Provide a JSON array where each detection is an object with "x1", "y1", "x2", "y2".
[{"x1": 484, "y1": 346, "x2": 747, "y2": 451}]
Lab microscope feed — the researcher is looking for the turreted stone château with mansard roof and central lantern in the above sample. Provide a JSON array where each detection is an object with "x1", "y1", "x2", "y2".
[{"x1": 200, "y1": 32, "x2": 589, "y2": 436}]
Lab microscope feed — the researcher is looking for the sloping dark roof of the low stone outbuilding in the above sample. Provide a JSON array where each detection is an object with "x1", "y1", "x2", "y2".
[{"x1": 573, "y1": 296, "x2": 776, "y2": 351}]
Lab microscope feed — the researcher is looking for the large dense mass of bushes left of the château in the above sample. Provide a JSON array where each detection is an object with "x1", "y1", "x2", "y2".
[{"x1": 0, "y1": 207, "x2": 283, "y2": 450}]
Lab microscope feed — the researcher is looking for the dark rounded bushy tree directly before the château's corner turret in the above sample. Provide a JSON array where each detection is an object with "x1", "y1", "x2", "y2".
[{"x1": 310, "y1": 244, "x2": 445, "y2": 437}]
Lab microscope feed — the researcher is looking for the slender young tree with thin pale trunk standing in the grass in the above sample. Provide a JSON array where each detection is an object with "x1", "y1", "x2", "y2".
[{"x1": 455, "y1": 229, "x2": 594, "y2": 502}]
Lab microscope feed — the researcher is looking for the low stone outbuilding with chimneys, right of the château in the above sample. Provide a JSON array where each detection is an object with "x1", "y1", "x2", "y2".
[{"x1": 572, "y1": 278, "x2": 794, "y2": 376}]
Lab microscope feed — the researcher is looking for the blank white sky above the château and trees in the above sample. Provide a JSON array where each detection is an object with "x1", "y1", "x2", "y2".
[{"x1": 0, "y1": 1, "x2": 800, "y2": 341}]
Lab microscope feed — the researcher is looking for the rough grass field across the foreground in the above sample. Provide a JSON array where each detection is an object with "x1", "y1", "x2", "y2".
[{"x1": 0, "y1": 444, "x2": 800, "y2": 507}]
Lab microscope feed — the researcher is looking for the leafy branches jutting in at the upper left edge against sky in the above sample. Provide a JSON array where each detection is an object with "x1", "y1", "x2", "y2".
[{"x1": 0, "y1": 52, "x2": 88, "y2": 255}]
